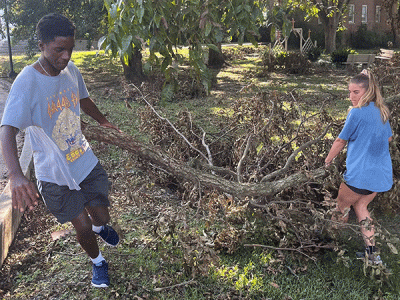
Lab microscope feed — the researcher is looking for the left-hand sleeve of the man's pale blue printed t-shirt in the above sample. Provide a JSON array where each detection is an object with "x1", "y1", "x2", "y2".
[{"x1": 1, "y1": 85, "x2": 32, "y2": 130}]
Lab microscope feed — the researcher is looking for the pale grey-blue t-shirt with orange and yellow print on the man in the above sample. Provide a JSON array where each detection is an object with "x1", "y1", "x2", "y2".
[{"x1": 1, "y1": 61, "x2": 98, "y2": 190}]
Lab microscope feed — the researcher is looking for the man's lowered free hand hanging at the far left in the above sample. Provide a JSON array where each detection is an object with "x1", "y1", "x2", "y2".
[{"x1": 10, "y1": 176, "x2": 39, "y2": 212}]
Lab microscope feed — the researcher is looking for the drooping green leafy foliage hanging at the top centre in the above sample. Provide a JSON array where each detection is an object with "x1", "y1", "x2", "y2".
[{"x1": 99, "y1": 0, "x2": 262, "y2": 95}]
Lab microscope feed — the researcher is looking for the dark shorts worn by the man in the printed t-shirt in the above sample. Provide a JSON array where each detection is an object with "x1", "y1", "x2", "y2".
[{"x1": 38, "y1": 163, "x2": 110, "y2": 224}]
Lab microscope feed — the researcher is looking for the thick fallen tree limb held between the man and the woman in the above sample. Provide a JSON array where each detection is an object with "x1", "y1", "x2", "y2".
[{"x1": 83, "y1": 125, "x2": 328, "y2": 199}]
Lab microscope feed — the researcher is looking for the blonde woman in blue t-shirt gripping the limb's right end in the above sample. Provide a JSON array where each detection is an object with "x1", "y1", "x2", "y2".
[{"x1": 325, "y1": 70, "x2": 393, "y2": 264}]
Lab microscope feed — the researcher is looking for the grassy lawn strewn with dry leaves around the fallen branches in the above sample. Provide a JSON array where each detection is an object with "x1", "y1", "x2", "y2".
[{"x1": 0, "y1": 48, "x2": 400, "y2": 300}]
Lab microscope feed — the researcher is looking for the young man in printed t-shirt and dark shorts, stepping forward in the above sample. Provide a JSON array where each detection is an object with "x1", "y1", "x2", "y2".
[{"x1": 0, "y1": 14, "x2": 119, "y2": 287}]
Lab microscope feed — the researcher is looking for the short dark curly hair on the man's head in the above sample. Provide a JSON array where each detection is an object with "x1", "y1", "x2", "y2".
[{"x1": 36, "y1": 13, "x2": 76, "y2": 43}]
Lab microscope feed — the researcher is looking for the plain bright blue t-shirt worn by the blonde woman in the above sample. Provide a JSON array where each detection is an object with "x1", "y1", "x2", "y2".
[{"x1": 339, "y1": 102, "x2": 393, "y2": 192}]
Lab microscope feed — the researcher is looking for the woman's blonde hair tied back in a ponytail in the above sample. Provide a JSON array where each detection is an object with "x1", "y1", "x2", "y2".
[{"x1": 350, "y1": 70, "x2": 390, "y2": 123}]
